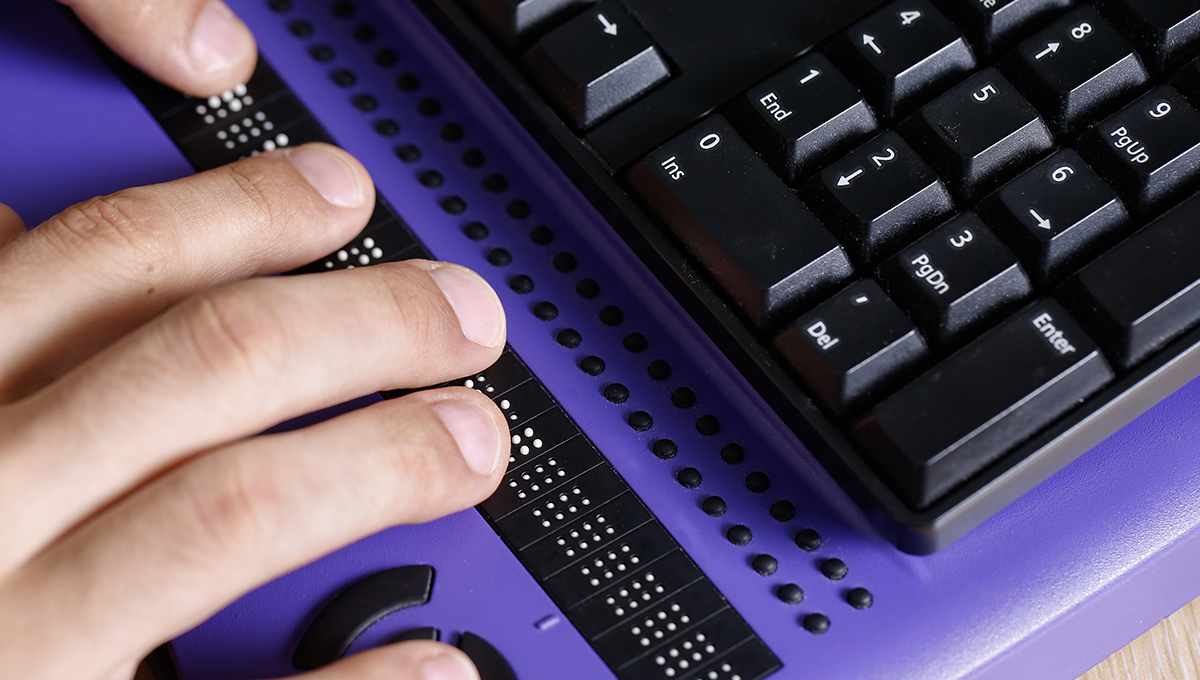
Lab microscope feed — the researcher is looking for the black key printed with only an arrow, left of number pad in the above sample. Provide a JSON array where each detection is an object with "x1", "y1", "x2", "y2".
[{"x1": 526, "y1": 0, "x2": 671, "y2": 130}]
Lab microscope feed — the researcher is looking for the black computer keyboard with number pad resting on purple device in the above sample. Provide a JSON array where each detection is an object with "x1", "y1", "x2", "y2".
[{"x1": 417, "y1": 0, "x2": 1200, "y2": 553}]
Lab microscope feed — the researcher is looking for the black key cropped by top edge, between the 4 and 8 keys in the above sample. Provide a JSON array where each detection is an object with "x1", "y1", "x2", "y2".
[{"x1": 940, "y1": 0, "x2": 1070, "y2": 56}]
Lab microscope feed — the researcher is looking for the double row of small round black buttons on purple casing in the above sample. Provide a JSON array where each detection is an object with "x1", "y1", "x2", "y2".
[{"x1": 270, "y1": 0, "x2": 872, "y2": 633}]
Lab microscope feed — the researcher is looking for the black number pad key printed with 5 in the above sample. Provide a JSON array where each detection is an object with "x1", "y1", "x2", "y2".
[{"x1": 904, "y1": 68, "x2": 1054, "y2": 200}]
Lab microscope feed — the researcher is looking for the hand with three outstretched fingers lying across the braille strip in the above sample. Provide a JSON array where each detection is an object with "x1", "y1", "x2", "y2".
[{"x1": 0, "y1": 2, "x2": 508, "y2": 680}]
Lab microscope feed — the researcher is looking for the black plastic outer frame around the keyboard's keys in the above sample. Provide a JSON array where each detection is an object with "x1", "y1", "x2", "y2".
[{"x1": 416, "y1": 0, "x2": 1200, "y2": 554}]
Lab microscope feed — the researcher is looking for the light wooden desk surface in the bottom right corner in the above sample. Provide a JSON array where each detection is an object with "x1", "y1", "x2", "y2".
[{"x1": 1079, "y1": 598, "x2": 1200, "y2": 680}]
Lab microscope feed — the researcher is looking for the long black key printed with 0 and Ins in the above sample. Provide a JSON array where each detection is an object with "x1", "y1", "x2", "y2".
[{"x1": 629, "y1": 115, "x2": 852, "y2": 326}]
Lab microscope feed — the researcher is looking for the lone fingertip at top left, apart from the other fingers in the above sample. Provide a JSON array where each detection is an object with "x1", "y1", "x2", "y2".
[{"x1": 59, "y1": 0, "x2": 257, "y2": 97}]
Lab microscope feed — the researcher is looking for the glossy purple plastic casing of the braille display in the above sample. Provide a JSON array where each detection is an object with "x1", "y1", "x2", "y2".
[{"x1": 7, "y1": 0, "x2": 1200, "y2": 680}]
